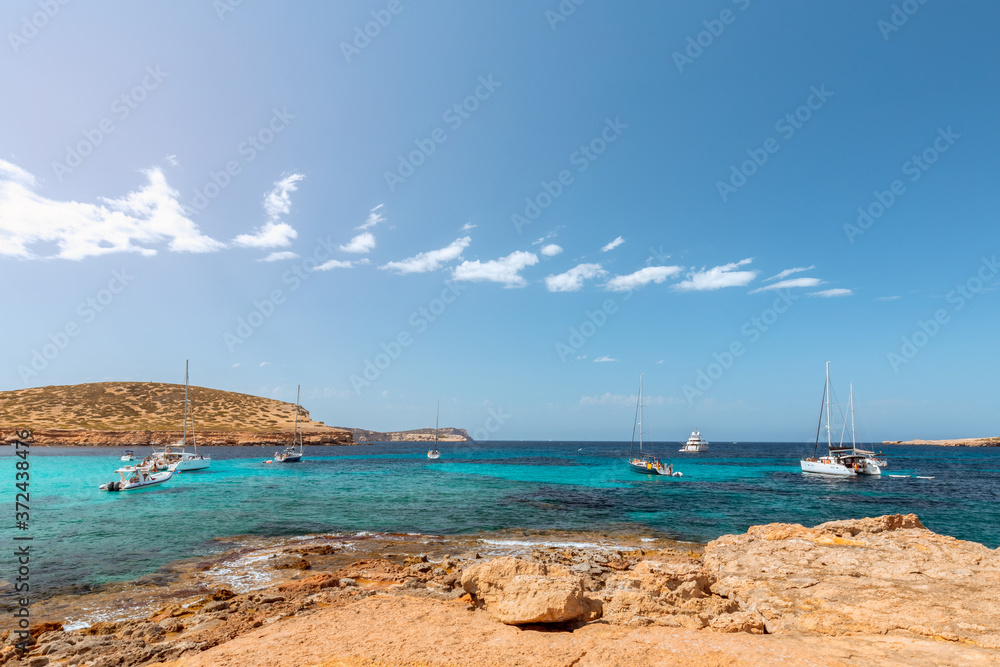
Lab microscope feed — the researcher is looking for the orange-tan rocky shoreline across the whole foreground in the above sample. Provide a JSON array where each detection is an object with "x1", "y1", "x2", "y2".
[{"x1": 0, "y1": 515, "x2": 1000, "y2": 667}]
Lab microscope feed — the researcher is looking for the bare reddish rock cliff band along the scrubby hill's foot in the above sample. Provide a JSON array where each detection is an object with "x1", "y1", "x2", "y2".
[{"x1": 0, "y1": 427, "x2": 357, "y2": 447}]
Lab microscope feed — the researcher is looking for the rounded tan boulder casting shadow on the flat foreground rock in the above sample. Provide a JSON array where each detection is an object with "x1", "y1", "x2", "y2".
[{"x1": 462, "y1": 556, "x2": 602, "y2": 625}]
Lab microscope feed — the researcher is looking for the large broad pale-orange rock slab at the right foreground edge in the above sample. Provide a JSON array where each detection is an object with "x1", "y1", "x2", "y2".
[{"x1": 704, "y1": 514, "x2": 1000, "y2": 648}]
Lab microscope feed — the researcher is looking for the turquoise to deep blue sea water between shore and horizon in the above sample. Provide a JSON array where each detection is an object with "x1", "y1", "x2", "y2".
[{"x1": 0, "y1": 442, "x2": 1000, "y2": 595}]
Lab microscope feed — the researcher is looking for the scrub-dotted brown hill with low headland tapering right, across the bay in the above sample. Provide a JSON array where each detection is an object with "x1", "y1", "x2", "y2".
[{"x1": 0, "y1": 382, "x2": 462, "y2": 447}]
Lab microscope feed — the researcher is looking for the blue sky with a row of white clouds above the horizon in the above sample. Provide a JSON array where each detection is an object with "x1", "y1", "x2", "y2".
[{"x1": 0, "y1": 0, "x2": 1000, "y2": 441}]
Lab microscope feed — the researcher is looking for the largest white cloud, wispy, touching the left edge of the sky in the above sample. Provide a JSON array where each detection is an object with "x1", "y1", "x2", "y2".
[{"x1": 0, "y1": 160, "x2": 225, "y2": 260}]
